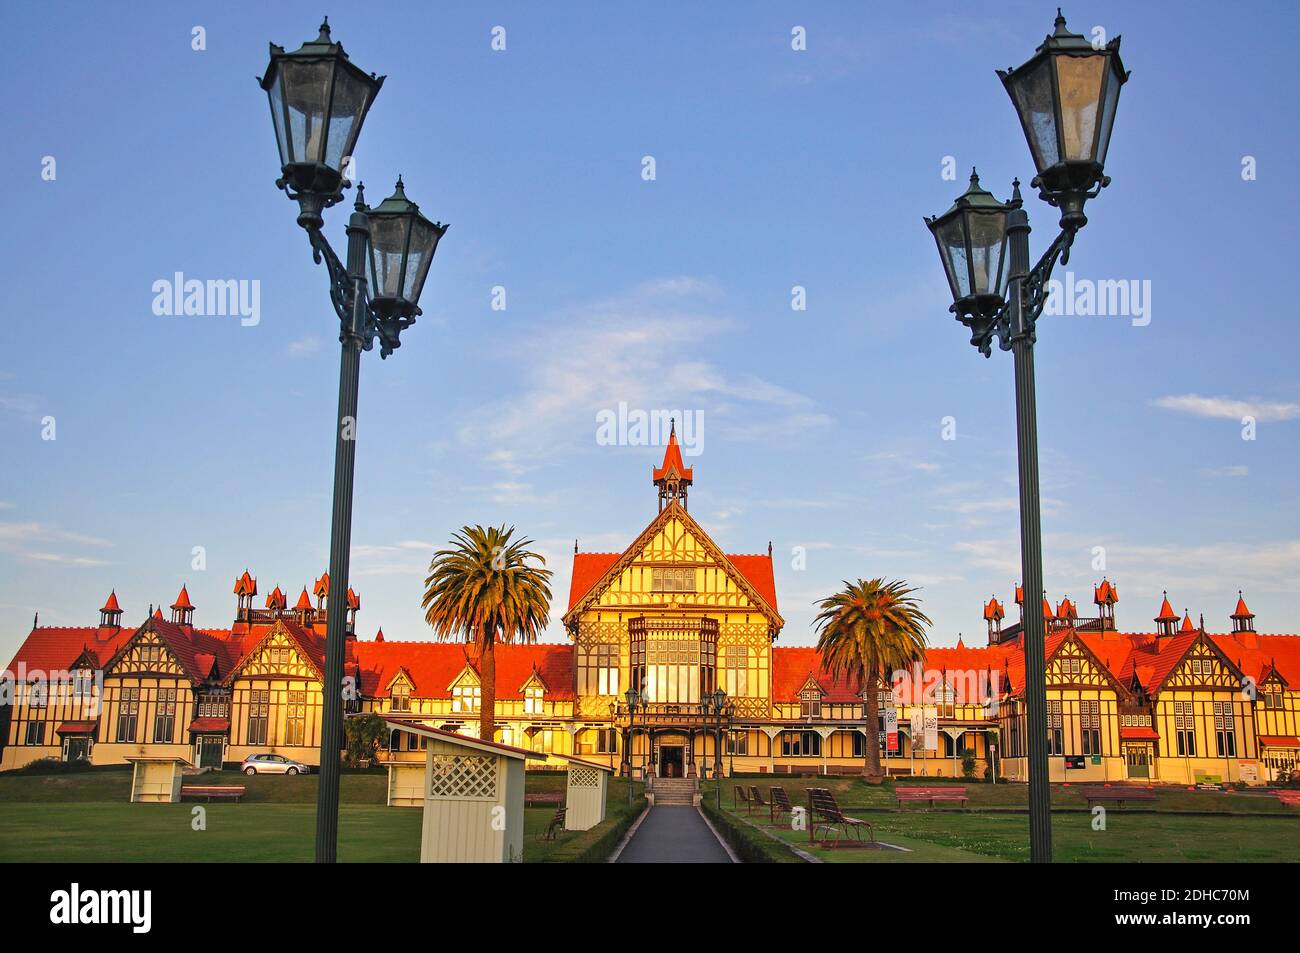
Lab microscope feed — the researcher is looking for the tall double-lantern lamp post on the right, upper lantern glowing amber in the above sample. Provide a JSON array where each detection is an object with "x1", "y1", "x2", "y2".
[{"x1": 926, "y1": 10, "x2": 1128, "y2": 863}]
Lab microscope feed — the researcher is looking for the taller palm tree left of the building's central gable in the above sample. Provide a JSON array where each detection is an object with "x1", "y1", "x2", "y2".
[{"x1": 420, "y1": 525, "x2": 551, "y2": 741}]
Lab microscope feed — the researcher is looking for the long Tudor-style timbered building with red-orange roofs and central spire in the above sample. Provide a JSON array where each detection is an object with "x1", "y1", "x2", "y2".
[{"x1": 0, "y1": 433, "x2": 1300, "y2": 784}]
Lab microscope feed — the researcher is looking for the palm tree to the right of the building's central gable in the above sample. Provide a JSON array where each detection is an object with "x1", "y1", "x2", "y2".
[{"x1": 815, "y1": 579, "x2": 932, "y2": 784}]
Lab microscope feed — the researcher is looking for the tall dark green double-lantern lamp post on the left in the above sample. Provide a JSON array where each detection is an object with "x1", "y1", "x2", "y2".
[{"x1": 260, "y1": 20, "x2": 447, "y2": 863}]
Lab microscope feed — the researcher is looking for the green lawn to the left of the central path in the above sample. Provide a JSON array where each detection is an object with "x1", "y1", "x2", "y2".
[{"x1": 0, "y1": 770, "x2": 645, "y2": 863}]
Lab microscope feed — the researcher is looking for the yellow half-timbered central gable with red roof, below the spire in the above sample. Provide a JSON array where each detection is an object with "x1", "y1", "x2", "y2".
[{"x1": 564, "y1": 502, "x2": 784, "y2": 629}]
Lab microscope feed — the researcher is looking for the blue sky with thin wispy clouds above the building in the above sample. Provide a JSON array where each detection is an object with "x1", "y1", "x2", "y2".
[{"x1": 0, "y1": 3, "x2": 1300, "y2": 658}]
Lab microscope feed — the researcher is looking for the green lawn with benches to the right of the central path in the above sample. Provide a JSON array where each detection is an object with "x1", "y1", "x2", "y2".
[{"x1": 710, "y1": 779, "x2": 1300, "y2": 863}]
